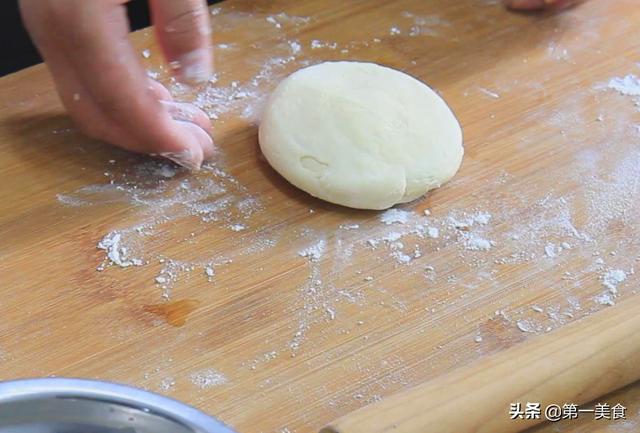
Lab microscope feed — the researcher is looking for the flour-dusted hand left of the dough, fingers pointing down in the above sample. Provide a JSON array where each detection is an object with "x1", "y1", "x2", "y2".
[{"x1": 20, "y1": 0, "x2": 214, "y2": 170}]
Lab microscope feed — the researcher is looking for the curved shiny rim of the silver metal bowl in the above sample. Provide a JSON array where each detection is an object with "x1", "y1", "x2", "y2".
[{"x1": 0, "y1": 378, "x2": 234, "y2": 433}]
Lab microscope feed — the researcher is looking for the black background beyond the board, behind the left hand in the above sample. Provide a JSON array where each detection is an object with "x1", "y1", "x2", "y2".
[{"x1": 0, "y1": 0, "x2": 220, "y2": 76}]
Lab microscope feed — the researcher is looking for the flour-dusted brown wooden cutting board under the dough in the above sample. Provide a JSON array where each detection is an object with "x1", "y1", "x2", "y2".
[{"x1": 0, "y1": 0, "x2": 640, "y2": 433}]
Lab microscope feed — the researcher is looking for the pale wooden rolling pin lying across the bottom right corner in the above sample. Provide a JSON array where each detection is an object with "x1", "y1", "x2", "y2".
[{"x1": 321, "y1": 297, "x2": 640, "y2": 433}]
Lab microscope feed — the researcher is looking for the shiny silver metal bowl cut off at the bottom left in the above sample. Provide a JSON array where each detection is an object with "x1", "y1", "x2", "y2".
[{"x1": 0, "y1": 378, "x2": 234, "y2": 433}]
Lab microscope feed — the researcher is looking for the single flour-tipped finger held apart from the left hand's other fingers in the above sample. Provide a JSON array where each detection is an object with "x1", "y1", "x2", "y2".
[{"x1": 151, "y1": 0, "x2": 213, "y2": 83}]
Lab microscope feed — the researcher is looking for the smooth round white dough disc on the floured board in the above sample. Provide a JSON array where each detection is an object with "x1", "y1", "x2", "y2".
[{"x1": 259, "y1": 62, "x2": 464, "y2": 209}]
